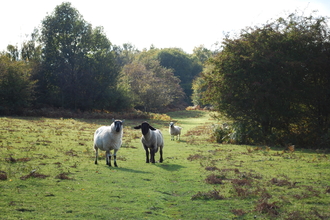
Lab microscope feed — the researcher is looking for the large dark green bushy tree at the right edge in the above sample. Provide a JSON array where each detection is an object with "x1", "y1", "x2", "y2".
[{"x1": 194, "y1": 14, "x2": 330, "y2": 148}]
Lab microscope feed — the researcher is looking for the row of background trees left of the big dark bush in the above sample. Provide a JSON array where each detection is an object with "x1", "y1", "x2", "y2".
[{"x1": 0, "y1": 3, "x2": 212, "y2": 114}]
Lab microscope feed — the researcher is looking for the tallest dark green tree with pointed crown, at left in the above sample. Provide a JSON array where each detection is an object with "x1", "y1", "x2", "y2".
[{"x1": 36, "y1": 3, "x2": 119, "y2": 110}]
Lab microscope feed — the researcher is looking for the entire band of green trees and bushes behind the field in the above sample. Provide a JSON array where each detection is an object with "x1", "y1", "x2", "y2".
[{"x1": 0, "y1": 3, "x2": 330, "y2": 148}]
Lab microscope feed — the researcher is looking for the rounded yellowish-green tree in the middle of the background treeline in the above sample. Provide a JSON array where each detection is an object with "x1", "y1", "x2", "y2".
[{"x1": 123, "y1": 60, "x2": 183, "y2": 111}]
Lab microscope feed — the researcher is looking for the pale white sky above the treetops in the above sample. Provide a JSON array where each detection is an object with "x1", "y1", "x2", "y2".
[{"x1": 0, "y1": 0, "x2": 330, "y2": 53}]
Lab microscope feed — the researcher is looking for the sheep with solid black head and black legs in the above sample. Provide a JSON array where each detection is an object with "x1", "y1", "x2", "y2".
[{"x1": 134, "y1": 122, "x2": 164, "y2": 163}]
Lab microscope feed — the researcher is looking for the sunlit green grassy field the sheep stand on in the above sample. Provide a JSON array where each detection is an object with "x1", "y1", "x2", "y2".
[{"x1": 0, "y1": 111, "x2": 330, "y2": 219}]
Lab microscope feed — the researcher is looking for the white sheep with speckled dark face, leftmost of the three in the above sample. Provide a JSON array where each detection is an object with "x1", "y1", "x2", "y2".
[{"x1": 93, "y1": 119, "x2": 125, "y2": 167}]
